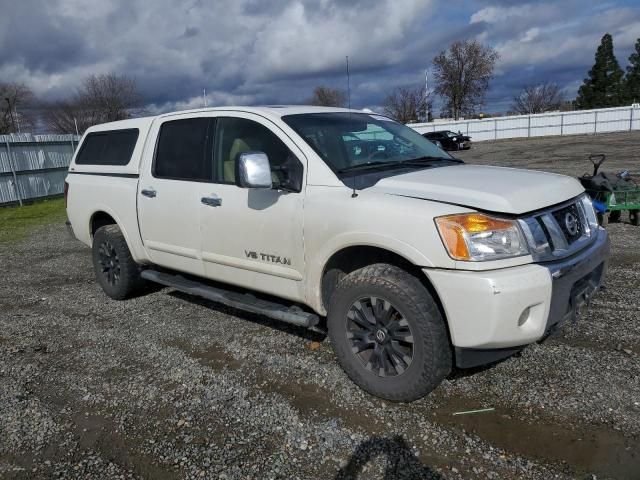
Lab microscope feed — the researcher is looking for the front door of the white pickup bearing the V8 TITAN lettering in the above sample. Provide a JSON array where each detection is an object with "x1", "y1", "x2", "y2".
[{"x1": 201, "y1": 112, "x2": 306, "y2": 301}]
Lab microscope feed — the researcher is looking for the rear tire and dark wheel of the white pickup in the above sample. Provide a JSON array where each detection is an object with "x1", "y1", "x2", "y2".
[{"x1": 92, "y1": 225, "x2": 144, "y2": 300}]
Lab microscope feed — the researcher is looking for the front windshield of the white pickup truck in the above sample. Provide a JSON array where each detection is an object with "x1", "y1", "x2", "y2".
[{"x1": 282, "y1": 112, "x2": 452, "y2": 173}]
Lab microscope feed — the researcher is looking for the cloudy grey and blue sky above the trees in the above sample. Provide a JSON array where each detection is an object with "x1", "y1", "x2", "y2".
[{"x1": 0, "y1": 0, "x2": 640, "y2": 113}]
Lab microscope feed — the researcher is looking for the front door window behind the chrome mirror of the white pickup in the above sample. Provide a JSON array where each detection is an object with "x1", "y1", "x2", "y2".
[{"x1": 214, "y1": 117, "x2": 302, "y2": 188}]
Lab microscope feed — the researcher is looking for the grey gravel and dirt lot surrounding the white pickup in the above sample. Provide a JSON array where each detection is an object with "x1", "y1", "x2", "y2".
[{"x1": 0, "y1": 133, "x2": 640, "y2": 479}]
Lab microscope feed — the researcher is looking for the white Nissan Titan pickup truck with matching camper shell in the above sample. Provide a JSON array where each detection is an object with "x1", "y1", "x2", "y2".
[{"x1": 65, "y1": 106, "x2": 609, "y2": 401}]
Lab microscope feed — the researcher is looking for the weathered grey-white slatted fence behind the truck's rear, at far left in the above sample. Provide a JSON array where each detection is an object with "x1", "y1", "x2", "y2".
[{"x1": 0, "y1": 133, "x2": 80, "y2": 205}]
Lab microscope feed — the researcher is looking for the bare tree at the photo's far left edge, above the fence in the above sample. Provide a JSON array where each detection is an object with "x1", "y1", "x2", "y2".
[{"x1": 0, "y1": 82, "x2": 35, "y2": 134}]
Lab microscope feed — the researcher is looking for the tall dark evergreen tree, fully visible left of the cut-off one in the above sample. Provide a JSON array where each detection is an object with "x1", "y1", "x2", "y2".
[{"x1": 576, "y1": 33, "x2": 624, "y2": 109}]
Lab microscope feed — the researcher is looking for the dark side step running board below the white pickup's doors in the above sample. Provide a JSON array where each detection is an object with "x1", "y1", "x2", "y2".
[{"x1": 141, "y1": 270, "x2": 319, "y2": 328}]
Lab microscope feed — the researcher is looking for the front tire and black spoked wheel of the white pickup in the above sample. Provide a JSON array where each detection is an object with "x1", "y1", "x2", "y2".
[{"x1": 327, "y1": 264, "x2": 451, "y2": 402}]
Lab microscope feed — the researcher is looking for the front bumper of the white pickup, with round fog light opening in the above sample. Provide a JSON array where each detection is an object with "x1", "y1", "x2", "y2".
[{"x1": 424, "y1": 229, "x2": 609, "y2": 366}]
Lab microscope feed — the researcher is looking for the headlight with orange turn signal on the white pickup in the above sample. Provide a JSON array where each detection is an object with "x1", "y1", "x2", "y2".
[{"x1": 436, "y1": 213, "x2": 529, "y2": 262}]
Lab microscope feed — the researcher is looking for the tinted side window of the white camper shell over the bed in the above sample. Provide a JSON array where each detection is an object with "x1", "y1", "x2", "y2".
[{"x1": 76, "y1": 128, "x2": 139, "y2": 166}]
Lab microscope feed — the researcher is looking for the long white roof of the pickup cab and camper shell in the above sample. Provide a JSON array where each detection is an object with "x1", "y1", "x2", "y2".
[{"x1": 89, "y1": 105, "x2": 370, "y2": 132}]
